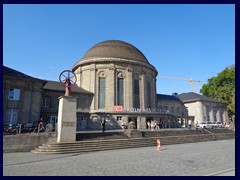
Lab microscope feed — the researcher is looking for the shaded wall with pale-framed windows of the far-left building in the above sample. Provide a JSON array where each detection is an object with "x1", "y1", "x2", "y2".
[{"x1": 3, "y1": 76, "x2": 44, "y2": 125}]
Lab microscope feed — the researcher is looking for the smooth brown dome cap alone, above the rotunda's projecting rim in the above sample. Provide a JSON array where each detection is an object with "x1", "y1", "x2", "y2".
[{"x1": 80, "y1": 40, "x2": 149, "y2": 63}]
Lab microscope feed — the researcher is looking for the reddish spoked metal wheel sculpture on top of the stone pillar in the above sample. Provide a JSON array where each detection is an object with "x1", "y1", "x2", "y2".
[{"x1": 59, "y1": 70, "x2": 77, "y2": 96}]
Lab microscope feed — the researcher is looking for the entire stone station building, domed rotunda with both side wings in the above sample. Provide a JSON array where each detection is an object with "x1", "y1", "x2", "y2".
[{"x1": 3, "y1": 40, "x2": 228, "y2": 130}]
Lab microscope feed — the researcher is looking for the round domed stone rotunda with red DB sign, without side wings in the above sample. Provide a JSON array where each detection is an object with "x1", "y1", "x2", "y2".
[{"x1": 73, "y1": 40, "x2": 158, "y2": 128}]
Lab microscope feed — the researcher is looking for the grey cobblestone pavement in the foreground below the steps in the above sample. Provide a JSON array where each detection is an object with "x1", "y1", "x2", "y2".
[{"x1": 3, "y1": 139, "x2": 235, "y2": 176}]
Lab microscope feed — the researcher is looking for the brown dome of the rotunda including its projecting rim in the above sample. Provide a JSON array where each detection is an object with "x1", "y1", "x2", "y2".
[{"x1": 72, "y1": 40, "x2": 157, "y2": 74}]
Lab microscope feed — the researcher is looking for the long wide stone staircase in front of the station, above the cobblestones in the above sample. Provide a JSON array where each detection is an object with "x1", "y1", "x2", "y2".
[{"x1": 31, "y1": 129, "x2": 235, "y2": 154}]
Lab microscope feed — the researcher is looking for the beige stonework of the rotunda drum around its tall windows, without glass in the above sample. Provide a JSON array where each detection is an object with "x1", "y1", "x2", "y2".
[{"x1": 75, "y1": 63, "x2": 156, "y2": 113}]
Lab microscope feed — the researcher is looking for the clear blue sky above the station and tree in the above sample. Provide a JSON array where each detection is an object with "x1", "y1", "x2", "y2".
[{"x1": 3, "y1": 4, "x2": 235, "y2": 95}]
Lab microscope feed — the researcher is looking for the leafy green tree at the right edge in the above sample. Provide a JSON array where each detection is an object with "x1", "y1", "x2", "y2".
[{"x1": 200, "y1": 65, "x2": 235, "y2": 121}]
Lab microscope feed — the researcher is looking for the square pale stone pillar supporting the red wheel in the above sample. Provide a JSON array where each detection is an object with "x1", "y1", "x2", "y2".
[{"x1": 57, "y1": 96, "x2": 77, "y2": 142}]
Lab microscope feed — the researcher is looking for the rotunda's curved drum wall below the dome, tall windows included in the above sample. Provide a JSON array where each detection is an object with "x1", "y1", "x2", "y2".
[{"x1": 75, "y1": 61, "x2": 156, "y2": 113}]
